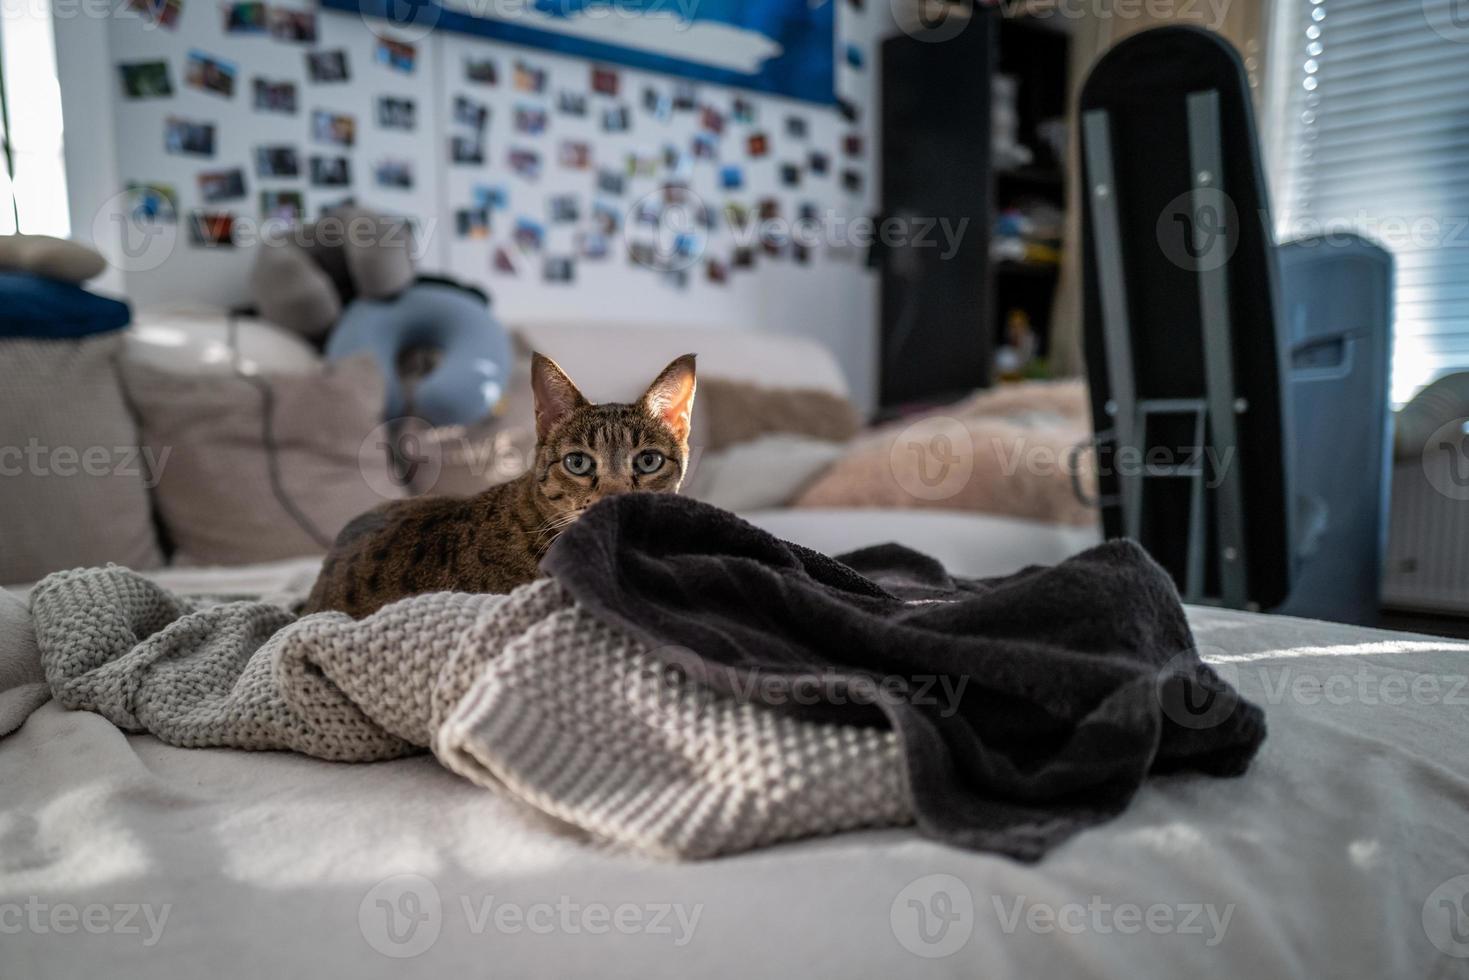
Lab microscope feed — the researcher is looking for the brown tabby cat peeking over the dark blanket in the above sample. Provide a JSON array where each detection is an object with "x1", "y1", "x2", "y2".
[{"x1": 303, "y1": 354, "x2": 695, "y2": 619}]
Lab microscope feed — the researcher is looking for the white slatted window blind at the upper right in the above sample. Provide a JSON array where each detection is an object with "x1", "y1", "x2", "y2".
[{"x1": 1269, "y1": 0, "x2": 1469, "y2": 404}]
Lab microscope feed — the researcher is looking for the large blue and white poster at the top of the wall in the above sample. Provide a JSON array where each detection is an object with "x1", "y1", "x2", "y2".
[{"x1": 322, "y1": 0, "x2": 836, "y2": 104}]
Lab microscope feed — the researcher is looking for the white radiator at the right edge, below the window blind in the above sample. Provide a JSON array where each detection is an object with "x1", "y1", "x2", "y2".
[{"x1": 1382, "y1": 447, "x2": 1469, "y2": 616}]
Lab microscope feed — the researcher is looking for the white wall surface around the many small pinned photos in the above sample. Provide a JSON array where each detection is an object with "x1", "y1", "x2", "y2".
[{"x1": 56, "y1": 0, "x2": 890, "y2": 406}]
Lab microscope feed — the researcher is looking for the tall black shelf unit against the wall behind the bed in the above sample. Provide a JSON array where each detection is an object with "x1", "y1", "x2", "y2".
[{"x1": 877, "y1": 7, "x2": 1068, "y2": 402}]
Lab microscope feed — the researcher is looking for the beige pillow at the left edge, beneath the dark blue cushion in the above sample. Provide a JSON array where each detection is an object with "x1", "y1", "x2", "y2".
[{"x1": 0, "y1": 334, "x2": 163, "y2": 583}]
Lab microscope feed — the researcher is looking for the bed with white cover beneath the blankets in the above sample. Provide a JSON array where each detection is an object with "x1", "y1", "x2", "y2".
[{"x1": 0, "y1": 561, "x2": 1469, "y2": 980}]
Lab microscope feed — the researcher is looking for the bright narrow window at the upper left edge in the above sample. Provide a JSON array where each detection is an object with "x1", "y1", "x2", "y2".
[{"x1": 0, "y1": 0, "x2": 69, "y2": 238}]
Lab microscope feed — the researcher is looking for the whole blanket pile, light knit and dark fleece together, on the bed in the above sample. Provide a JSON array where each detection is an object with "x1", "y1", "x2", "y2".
[{"x1": 31, "y1": 494, "x2": 1263, "y2": 860}]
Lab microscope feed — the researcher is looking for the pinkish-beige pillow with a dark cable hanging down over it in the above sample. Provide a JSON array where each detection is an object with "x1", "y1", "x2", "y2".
[{"x1": 123, "y1": 356, "x2": 401, "y2": 566}]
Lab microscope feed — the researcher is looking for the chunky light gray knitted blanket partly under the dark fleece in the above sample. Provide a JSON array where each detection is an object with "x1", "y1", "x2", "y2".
[{"x1": 31, "y1": 567, "x2": 912, "y2": 858}]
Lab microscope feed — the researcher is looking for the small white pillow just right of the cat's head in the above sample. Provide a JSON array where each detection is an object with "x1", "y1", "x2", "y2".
[{"x1": 683, "y1": 433, "x2": 846, "y2": 511}]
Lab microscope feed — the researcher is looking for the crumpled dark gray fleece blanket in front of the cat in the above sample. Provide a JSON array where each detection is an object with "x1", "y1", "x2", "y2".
[{"x1": 542, "y1": 494, "x2": 1265, "y2": 861}]
